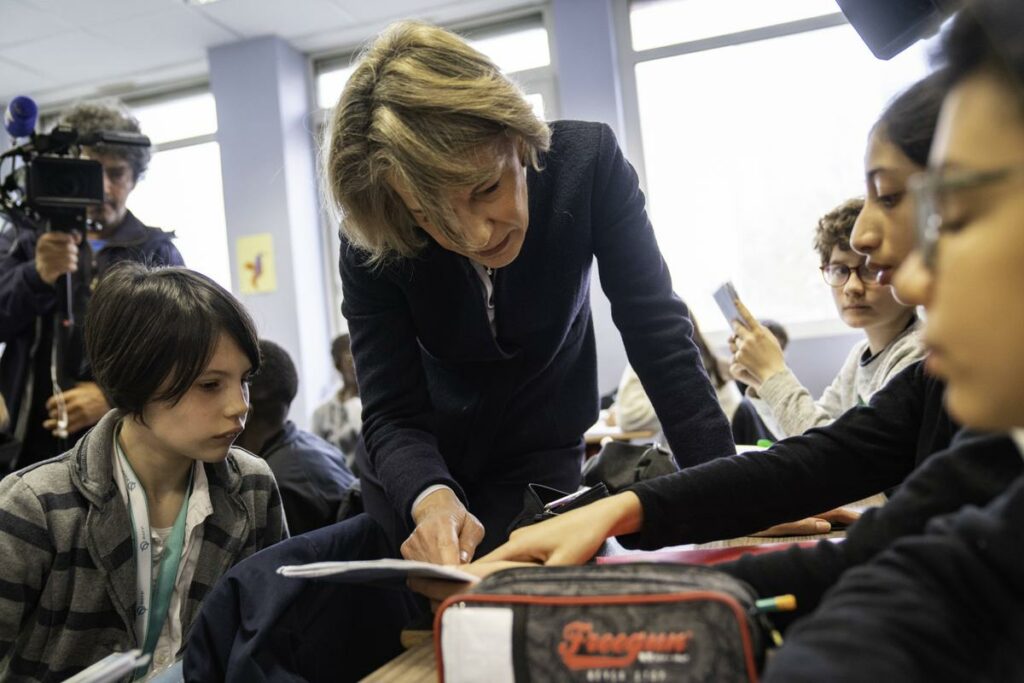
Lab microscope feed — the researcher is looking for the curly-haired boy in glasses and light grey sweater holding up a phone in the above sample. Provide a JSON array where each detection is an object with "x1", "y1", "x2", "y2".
[{"x1": 729, "y1": 199, "x2": 924, "y2": 438}]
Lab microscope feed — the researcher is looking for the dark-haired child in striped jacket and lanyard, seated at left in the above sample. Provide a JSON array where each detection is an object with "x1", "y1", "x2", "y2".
[{"x1": 0, "y1": 262, "x2": 287, "y2": 681}]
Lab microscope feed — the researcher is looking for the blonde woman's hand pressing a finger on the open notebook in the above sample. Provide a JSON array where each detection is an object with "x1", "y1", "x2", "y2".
[{"x1": 401, "y1": 488, "x2": 483, "y2": 565}]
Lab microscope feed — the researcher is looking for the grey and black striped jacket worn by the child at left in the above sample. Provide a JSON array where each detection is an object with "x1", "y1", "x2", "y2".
[{"x1": 0, "y1": 411, "x2": 288, "y2": 681}]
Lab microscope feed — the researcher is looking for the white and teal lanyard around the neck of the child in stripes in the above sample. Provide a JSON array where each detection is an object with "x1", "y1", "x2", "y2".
[{"x1": 115, "y1": 436, "x2": 195, "y2": 674}]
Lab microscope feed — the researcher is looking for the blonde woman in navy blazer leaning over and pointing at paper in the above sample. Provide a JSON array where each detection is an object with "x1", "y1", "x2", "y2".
[{"x1": 326, "y1": 22, "x2": 733, "y2": 564}]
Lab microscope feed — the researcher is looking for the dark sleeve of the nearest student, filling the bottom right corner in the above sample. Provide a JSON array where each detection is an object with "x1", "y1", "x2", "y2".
[{"x1": 764, "y1": 477, "x2": 1024, "y2": 683}]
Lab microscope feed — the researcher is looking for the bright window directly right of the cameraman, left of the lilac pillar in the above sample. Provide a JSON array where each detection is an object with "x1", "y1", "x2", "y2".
[{"x1": 128, "y1": 91, "x2": 231, "y2": 290}]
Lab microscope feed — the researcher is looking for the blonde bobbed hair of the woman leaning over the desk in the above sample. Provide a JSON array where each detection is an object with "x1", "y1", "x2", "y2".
[{"x1": 324, "y1": 22, "x2": 551, "y2": 265}]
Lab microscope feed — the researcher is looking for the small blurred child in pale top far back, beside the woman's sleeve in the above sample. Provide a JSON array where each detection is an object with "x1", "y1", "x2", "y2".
[{"x1": 312, "y1": 334, "x2": 362, "y2": 471}]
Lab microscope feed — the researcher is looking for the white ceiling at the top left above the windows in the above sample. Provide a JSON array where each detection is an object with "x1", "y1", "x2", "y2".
[{"x1": 0, "y1": 0, "x2": 537, "y2": 108}]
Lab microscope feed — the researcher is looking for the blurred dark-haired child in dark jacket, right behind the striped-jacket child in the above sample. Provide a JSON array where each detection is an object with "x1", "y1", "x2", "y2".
[{"x1": 236, "y1": 339, "x2": 355, "y2": 536}]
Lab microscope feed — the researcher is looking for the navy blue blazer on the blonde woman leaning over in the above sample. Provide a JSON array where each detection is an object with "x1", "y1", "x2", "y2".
[{"x1": 340, "y1": 121, "x2": 734, "y2": 519}]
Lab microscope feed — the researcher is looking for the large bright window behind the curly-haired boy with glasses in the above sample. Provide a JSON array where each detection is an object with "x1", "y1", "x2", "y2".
[{"x1": 618, "y1": 0, "x2": 928, "y2": 332}]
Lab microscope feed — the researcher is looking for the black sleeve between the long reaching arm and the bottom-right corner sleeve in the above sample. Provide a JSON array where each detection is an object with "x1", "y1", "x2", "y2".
[{"x1": 717, "y1": 434, "x2": 1024, "y2": 622}]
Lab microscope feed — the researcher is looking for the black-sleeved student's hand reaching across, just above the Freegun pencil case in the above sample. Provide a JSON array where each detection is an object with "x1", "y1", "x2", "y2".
[{"x1": 479, "y1": 492, "x2": 643, "y2": 564}]
